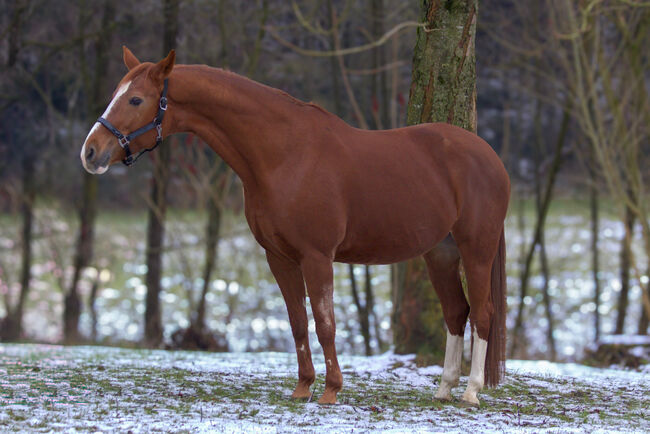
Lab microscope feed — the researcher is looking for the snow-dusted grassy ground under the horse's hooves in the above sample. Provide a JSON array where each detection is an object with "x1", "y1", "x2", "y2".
[{"x1": 0, "y1": 344, "x2": 650, "y2": 432}]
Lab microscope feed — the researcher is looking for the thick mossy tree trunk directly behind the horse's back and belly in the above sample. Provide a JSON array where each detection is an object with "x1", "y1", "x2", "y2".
[{"x1": 393, "y1": 0, "x2": 478, "y2": 362}]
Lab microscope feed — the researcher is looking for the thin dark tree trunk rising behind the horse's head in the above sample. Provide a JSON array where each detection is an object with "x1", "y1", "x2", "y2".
[{"x1": 144, "y1": 0, "x2": 180, "y2": 348}]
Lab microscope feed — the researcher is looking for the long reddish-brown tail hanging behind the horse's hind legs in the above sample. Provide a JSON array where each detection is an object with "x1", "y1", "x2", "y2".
[{"x1": 485, "y1": 229, "x2": 507, "y2": 387}]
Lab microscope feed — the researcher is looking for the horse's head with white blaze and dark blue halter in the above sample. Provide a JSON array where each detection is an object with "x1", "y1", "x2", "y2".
[{"x1": 80, "y1": 47, "x2": 176, "y2": 174}]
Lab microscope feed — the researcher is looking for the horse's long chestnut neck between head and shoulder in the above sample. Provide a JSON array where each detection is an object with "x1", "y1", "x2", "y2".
[{"x1": 169, "y1": 65, "x2": 298, "y2": 186}]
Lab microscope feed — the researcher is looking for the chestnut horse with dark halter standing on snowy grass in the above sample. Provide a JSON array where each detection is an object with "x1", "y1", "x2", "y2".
[{"x1": 81, "y1": 47, "x2": 510, "y2": 405}]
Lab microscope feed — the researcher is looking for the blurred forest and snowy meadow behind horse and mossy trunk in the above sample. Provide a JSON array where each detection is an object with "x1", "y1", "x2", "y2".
[{"x1": 0, "y1": 0, "x2": 650, "y2": 364}]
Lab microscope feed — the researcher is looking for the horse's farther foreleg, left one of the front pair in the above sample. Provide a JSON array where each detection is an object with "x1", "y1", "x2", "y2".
[{"x1": 266, "y1": 251, "x2": 315, "y2": 399}]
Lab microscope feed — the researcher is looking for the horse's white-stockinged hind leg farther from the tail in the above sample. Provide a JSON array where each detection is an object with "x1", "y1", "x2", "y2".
[{"x1": 424, "y1": 235, "x2": 469, "y2": 400}]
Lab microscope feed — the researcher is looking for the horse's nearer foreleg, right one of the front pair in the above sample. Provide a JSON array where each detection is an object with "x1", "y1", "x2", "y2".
[{"x1": 300, "y1": 255, "x2": 343, "y2": 404}]
